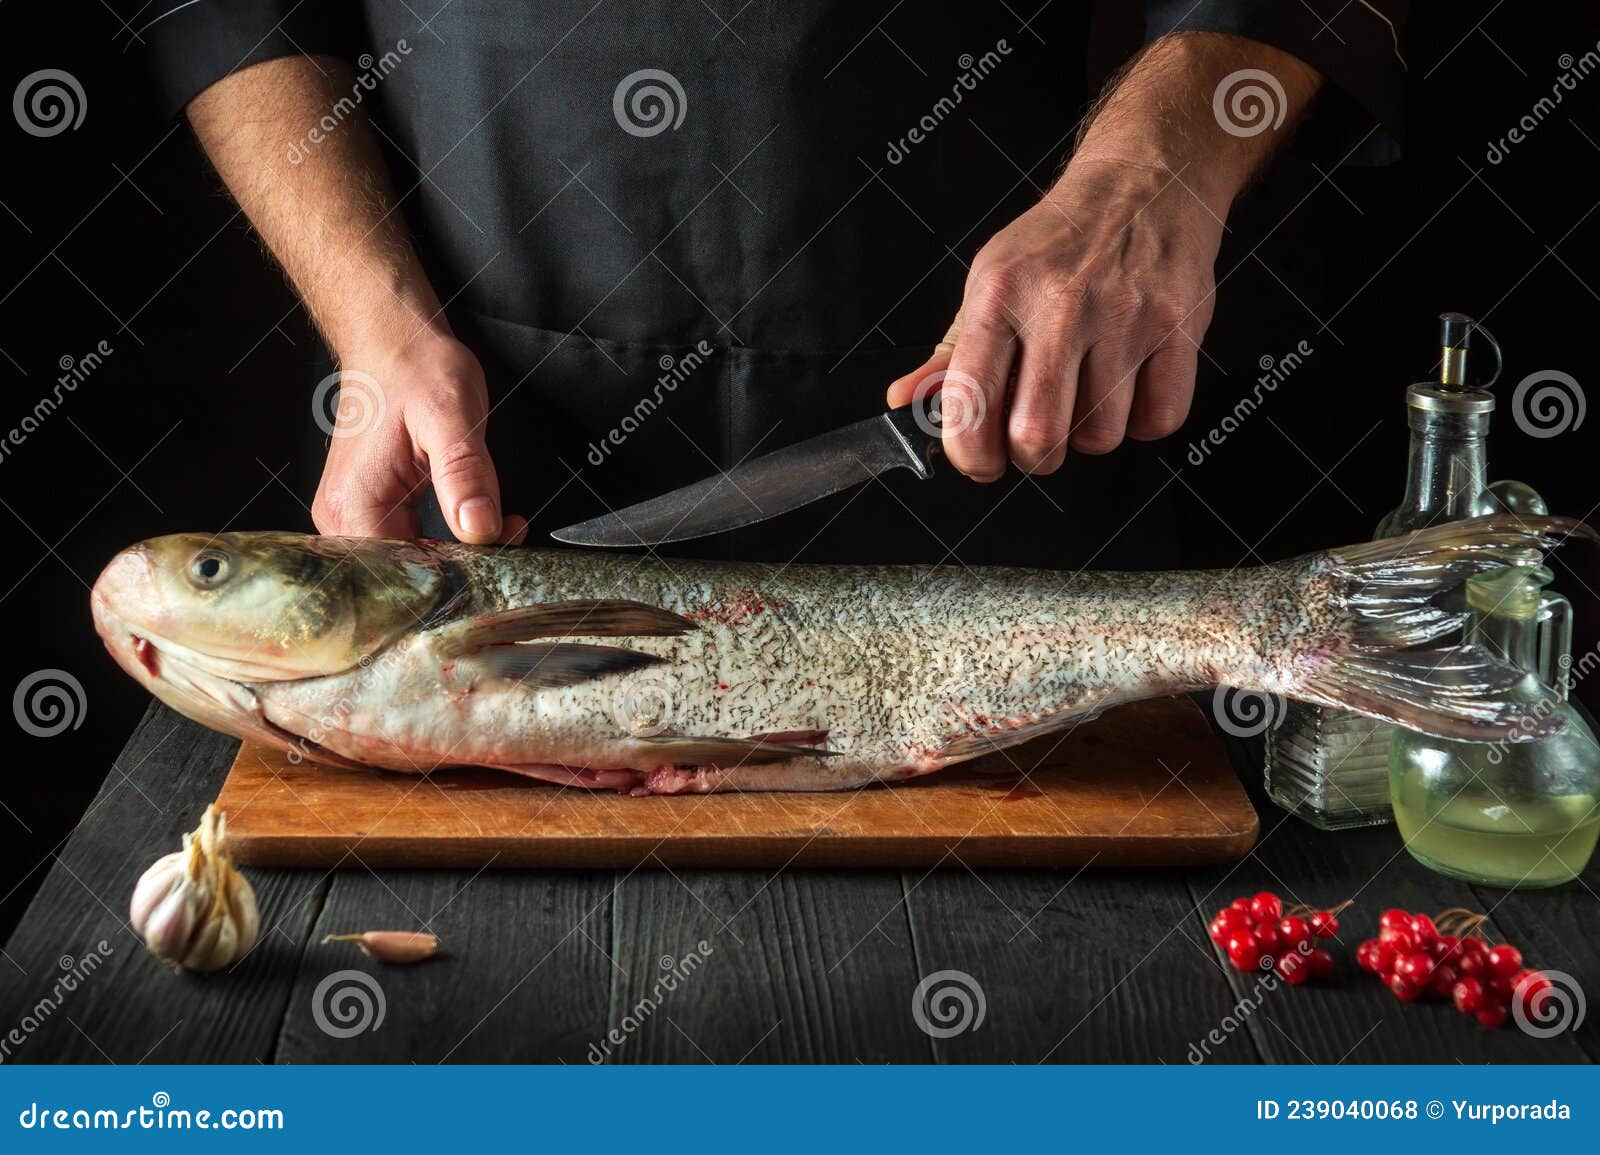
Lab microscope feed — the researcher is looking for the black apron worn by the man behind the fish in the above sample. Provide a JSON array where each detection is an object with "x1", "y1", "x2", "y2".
[{"x1": 324, "y1": 0, "x2": 1174, "y2": 568}]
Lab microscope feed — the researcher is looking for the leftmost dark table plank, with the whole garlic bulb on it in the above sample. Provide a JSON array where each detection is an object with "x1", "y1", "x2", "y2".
[{"x1": 0, "y1": 704, "x2": 325, "y2": 1064}]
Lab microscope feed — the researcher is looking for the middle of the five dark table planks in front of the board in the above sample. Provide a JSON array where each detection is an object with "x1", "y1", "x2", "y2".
[{"x1": 603, "y1": 870, "x2": 930, "y2": 1064}]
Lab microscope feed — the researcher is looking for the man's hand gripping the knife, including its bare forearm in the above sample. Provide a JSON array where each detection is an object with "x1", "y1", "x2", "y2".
[{"x1": 888, "y1": 34, "x2": 1318, "y2": 482}]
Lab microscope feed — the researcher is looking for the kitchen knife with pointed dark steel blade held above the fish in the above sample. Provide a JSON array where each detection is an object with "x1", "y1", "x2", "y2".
[{"x1": 550, "y1": 315, "x2": 962, "y2": 547}]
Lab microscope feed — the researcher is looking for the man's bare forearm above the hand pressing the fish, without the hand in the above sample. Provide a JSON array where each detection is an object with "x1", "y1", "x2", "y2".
[{"x1": 189, "y1": 56, "x2": 450, "y2": 362}]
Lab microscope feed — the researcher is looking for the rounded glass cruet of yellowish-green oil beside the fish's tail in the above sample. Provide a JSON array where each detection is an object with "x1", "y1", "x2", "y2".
[{"x1": 1389, "y1": 565, "x2": 1600, "y2": 888}]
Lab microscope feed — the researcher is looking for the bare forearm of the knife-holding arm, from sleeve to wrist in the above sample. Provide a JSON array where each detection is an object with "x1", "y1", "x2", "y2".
[{"x1": 1058, "y1": 32, "x2": 1322, "y2": 218}]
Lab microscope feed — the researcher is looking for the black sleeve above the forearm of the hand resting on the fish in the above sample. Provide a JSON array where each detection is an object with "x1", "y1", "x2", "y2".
[{"x1": 128, "y1": 0, "x2": 360, "y2": 118}]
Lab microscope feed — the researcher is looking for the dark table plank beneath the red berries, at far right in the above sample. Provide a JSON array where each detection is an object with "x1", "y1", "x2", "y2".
[{"x1": 1189, "y1": 739, "x2": 1600, "y2": 1064}]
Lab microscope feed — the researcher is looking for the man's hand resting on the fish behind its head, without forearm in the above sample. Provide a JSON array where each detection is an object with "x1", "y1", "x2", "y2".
[{"x1": 312, "y1": 338, "x2": 528, "y2": 544}]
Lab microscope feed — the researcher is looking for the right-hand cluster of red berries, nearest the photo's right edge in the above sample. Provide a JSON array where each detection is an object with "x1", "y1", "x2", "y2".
[{"x1": 1355, "y1": 909, "x2": 1550, "y2": 1027}]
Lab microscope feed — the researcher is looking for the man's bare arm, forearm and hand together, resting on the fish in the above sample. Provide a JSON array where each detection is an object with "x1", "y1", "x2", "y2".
[{"x1": 189, "y1": 56, "x2": 528, "y2": 546}]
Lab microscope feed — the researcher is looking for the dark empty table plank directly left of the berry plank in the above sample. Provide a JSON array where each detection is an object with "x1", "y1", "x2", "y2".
[{"x1": 907, "y1": 870, "x2": 1258, "y2": 1064}]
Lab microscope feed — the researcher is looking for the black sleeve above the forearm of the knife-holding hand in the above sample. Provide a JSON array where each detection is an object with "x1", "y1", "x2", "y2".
[{"x1": 1144, "y1": 0, "x2": 1410, "y2": 165}]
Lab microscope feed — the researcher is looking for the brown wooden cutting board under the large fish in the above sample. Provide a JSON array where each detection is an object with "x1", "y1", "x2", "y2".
[{"x1": 218, "y1": 697, "x2": 1258, "y2": 867}]
